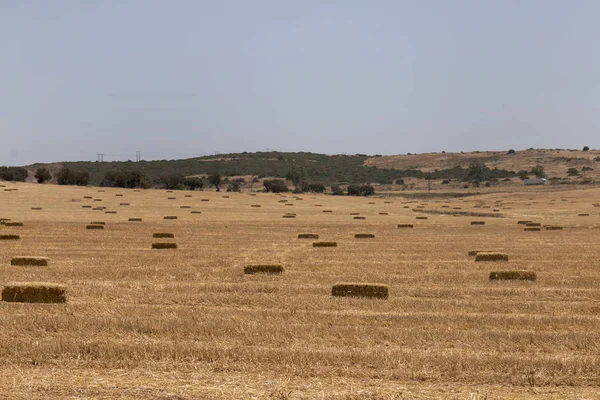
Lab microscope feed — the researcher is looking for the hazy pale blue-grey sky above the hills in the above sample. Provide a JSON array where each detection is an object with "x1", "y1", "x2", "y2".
[{"x1": 0, "y1": 0, "x2": 600, "y2": 165}]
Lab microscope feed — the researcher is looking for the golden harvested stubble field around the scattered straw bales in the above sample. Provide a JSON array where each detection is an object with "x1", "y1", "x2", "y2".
[{"x1": 0, "y1": 183, "x2": 600, "y2": 400}]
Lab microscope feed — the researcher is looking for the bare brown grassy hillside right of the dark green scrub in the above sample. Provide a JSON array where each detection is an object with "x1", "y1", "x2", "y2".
[{"x1": 365, "y1": 149, "x2": 600, "y2": 178}]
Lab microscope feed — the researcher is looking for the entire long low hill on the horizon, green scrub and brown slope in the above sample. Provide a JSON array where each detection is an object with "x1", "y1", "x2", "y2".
[{"x1": 21, "y1": 149, "x2": 600, "y2": 185}]
